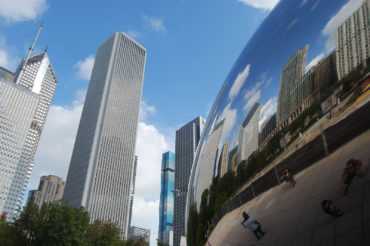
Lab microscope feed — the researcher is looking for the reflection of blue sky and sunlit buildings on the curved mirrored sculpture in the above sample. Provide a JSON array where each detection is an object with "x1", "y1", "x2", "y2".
[{"x1": 187, "y1": 0, "x2": 370, "y2": 222}]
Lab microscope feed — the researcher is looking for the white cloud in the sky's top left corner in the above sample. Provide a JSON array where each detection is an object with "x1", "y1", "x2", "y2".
[{"x1": 0, "y1": 0, "x2": 48, "y2": 22}]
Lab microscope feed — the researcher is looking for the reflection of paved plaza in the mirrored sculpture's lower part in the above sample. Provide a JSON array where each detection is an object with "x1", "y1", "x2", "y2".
[{"x1": 209, "y1": 130, "x2": 370, "y2": 246}]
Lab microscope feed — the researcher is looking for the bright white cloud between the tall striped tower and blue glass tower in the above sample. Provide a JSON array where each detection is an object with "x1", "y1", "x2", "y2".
[{"x1": 132, "y1": 122, "x2": 174, "y2": 245}]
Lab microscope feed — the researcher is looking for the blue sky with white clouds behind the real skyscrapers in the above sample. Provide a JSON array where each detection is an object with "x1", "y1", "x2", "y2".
[{"x1": 0, "y1": 0, "x2": 361, "y2": 245}]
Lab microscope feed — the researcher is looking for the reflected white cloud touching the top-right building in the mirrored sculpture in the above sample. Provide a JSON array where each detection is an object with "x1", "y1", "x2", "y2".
[{"x1": 321, "y1": 0, "x2": 363, "y2": 51}]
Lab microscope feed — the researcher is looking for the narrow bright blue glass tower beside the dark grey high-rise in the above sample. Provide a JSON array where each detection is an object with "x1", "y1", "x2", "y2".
[{"x1": 158, "y1": 152, "x2": 175, "y2": 244}]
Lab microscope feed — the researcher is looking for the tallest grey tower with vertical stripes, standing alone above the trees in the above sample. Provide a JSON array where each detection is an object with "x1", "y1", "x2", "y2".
[{"x1": 63, "y1": 33, "x2": 146, "y2": 238}]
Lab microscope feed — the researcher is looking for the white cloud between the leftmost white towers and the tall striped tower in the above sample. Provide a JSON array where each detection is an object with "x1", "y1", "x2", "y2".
[{"x1": 29, "y1": 90, "x2": 86, "y2": 189}]
